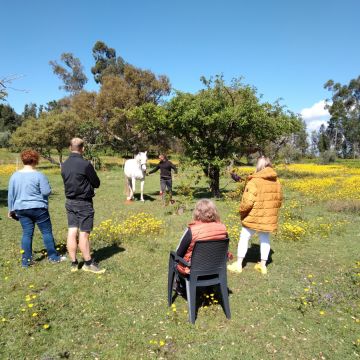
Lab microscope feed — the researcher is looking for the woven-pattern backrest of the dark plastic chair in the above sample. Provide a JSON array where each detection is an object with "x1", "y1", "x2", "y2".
[{"x1": 191, "y1": 239, "x2": 229, "y2": 274}]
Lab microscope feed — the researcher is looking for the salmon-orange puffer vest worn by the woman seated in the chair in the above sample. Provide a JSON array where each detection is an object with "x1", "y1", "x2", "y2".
[{"x1": 177, "y1": 221, "x2": 227, "y2": 275}]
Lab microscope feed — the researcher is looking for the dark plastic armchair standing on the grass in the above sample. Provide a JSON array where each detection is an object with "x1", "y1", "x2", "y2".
[{"x1": 168, "y1": 239, "x2": 231, "y2": 324}]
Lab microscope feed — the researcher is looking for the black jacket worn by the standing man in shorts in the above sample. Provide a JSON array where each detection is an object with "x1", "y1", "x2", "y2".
[{"x1": 61, "y1": 153, "x2": 100, "y2": 201}]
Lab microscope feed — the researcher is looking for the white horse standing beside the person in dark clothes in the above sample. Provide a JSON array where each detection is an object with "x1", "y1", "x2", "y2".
[{"x1": 124, "y1": 151, "x2": 147, "y2": 201}]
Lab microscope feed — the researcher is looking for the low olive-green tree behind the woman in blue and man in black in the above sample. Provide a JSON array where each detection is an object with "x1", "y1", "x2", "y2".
[{"x1": 10, "y1": 112, "x2": 79, "y2": 164}]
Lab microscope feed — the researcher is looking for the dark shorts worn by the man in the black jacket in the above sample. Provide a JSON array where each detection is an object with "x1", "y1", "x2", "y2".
[{"x1": 65, "y1": 199, "x2": 94, "y2": 232}]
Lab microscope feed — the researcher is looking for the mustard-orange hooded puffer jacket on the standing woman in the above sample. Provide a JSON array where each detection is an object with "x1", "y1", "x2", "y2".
[{"x1": 240, "y1": 167, "x2": 282, "y2": 232}]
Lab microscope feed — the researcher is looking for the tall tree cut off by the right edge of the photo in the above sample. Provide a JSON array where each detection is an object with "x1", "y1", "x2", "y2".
[{"x1": 324, "y1": 76, "x2": 360, "y2": 157}]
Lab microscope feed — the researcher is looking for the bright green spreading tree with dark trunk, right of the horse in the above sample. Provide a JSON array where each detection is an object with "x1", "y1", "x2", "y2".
[{"x1": 166, "y1": 76, "x2": 301, "y2": 196}]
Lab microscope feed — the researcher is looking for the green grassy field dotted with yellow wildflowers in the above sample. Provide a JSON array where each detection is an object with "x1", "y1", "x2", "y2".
[{"x1": 0, "y1": 156, "x2": 360, "y2": 360}]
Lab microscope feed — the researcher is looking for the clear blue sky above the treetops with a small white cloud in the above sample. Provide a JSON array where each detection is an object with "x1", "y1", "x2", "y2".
[{"x1": 0, "y1": 0, "x2": 360, "y2": 128}]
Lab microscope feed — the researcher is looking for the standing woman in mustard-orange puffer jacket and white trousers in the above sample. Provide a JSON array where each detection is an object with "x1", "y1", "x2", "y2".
[{"x1": 228, "y1": 156, "x2": 282, "y2": 274}]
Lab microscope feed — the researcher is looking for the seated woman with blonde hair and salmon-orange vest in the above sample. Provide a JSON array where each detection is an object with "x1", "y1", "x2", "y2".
[{"x1": 176, "y1": 199, "x2": 228, "y2": 275}]
